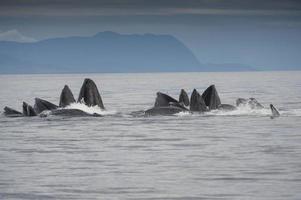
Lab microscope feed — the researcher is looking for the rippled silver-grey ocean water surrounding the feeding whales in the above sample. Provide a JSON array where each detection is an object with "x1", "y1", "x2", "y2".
[{"x1": 0, "y1": 72, "x2": 301, "y2": 200}]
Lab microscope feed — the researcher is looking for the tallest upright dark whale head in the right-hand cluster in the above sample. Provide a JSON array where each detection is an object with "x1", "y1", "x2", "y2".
[{"x1": 202, "y1": 85, "x2": 221, "y2": 110}]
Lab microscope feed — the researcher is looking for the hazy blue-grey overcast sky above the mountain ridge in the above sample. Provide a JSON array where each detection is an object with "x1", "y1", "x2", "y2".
[{"x1": 0, "y1": 0, "x2": 301, "y2": 67}]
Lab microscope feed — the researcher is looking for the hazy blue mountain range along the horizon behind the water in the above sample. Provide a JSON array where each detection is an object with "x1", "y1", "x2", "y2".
[{"x1": 0, "y1": 32, "x2": 254, "y2": 73}]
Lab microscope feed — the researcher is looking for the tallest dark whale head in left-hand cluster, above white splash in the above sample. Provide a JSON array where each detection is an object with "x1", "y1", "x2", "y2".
[{"x1": 77, "y1": 78, "x2": 105, "y2": 109}]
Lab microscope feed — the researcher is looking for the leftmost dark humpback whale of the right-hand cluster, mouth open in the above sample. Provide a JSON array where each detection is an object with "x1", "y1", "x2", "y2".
[{"x1": 144, "y1": 92, "x2": 188, "y2": 115}]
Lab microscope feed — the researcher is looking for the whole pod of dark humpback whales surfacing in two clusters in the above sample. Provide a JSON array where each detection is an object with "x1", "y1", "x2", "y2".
[{"x1": 4, "y1": 78, "x2": 280, "y2": 118}]
